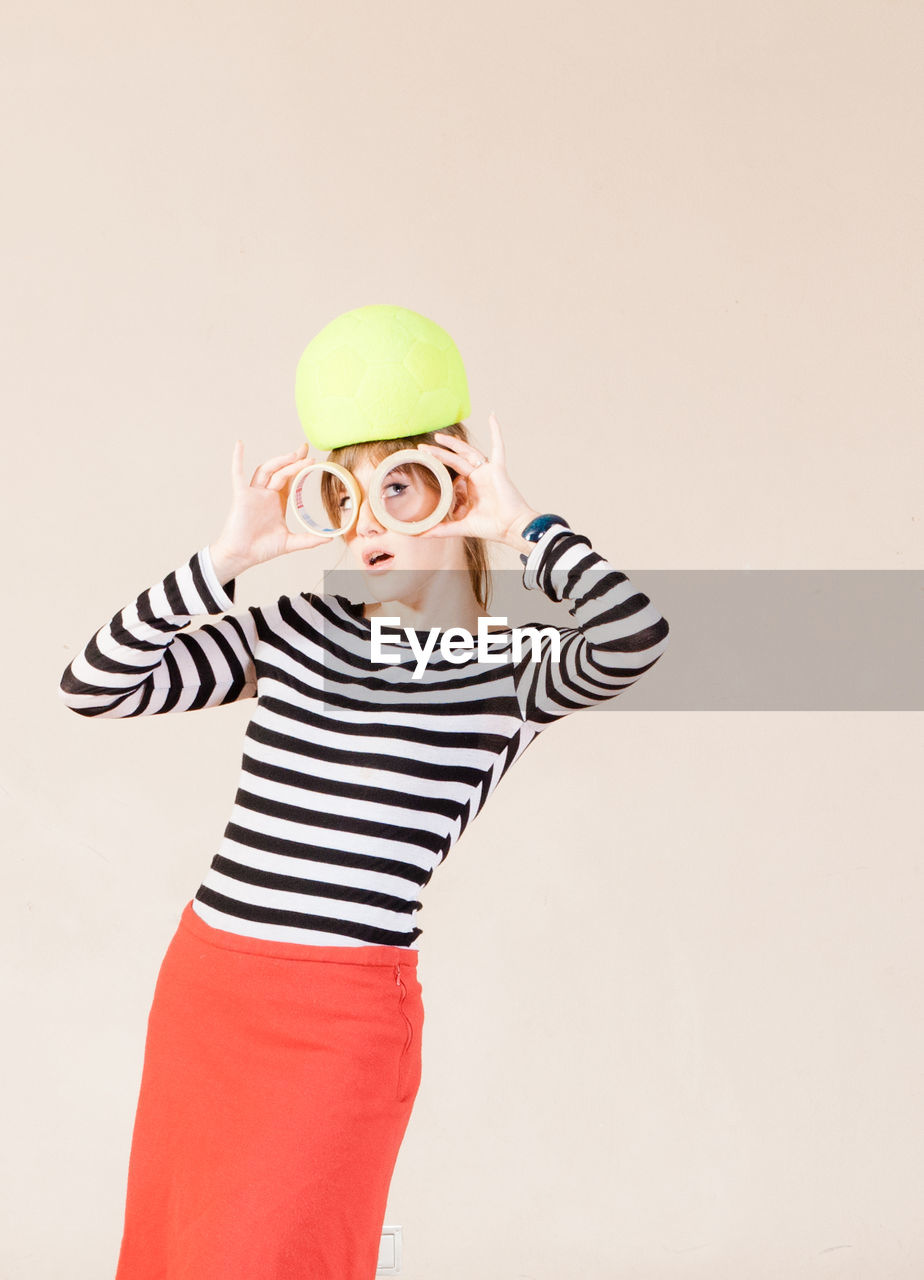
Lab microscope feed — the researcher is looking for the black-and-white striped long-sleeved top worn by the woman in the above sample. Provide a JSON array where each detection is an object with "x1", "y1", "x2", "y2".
[{"x1": 60, "y1": 524, "x2": 668, "y2": 947}]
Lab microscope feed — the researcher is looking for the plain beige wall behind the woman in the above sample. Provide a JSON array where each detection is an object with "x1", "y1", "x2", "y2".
[{"x1": 0, "y1": 0, "x2": 924, "y2": 1280}]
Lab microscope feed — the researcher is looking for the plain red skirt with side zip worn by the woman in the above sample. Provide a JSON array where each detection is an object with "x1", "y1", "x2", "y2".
[{"x1": 115, "y1": 901, "x2": 424, "y2": 1280}]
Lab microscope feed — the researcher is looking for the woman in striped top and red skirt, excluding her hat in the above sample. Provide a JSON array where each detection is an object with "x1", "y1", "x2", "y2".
[{"x1": 61, "y1": 416, "x2": 668, "y2": 1280}]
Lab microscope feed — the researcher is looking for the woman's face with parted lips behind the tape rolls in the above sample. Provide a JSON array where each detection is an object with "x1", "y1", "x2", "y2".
[{"x1": 342, "y1": 462, "x2": 466, "y2": 586}]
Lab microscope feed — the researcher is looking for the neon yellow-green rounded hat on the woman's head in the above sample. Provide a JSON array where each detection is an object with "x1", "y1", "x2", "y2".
[{"x1": 296, "y1": 303, "x2": 471, "y2": 449}]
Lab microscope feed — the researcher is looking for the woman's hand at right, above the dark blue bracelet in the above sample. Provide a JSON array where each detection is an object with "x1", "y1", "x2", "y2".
[{"x1": 417, "y1": 413, "x2": 536, "y2": 543}]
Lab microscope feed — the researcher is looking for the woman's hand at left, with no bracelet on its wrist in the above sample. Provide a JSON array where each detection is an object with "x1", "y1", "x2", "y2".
[{"x1": 209, "y1": 440, "x2": 329, "y2": 581}]
